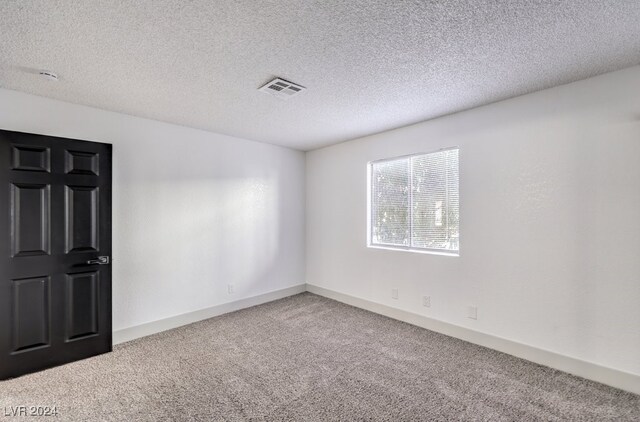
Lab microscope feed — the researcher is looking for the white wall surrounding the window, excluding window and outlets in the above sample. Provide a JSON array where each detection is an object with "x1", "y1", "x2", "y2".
[{"x1": 307, "y1": 67, "x2": 640, "y2": 374}]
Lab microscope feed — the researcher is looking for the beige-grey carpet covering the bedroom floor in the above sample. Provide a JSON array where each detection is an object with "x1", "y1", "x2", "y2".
[{"x1": 0, "y1": 293, "x2": 640, "y2": 421}]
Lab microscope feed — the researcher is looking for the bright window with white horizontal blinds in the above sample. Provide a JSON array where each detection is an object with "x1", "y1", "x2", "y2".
[{"x1": 369, "y1": 148, "x2": 460, "y2": 255}]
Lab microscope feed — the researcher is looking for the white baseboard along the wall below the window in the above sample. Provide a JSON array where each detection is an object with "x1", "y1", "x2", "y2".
[{"x1": 307, "y1": 284, "x2": 640, "y2": 394}]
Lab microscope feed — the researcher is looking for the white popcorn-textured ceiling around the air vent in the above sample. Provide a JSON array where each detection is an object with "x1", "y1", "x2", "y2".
[{"x1": 0, "y1": 0, "x2": 640, "y2": 150}]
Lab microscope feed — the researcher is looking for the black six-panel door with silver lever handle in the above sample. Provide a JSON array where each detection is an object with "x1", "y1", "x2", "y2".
[{"x1": 0, "y1": 130, "x2": 111, "y2": 379}]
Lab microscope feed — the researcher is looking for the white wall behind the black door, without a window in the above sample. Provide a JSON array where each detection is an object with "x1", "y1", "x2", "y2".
[{"x1": 0, "y1": 89, "x2": 305, "y2": 330}]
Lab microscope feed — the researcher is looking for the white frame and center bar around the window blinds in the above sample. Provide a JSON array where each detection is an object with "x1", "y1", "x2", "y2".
[{"x1": 367, "y1": 146, "x2": 462, "y2": 257}]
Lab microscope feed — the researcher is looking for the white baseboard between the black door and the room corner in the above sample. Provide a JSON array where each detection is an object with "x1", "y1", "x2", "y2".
[{"x1": 113, "y1": 284, "x2": 306, "y2": 344}]
